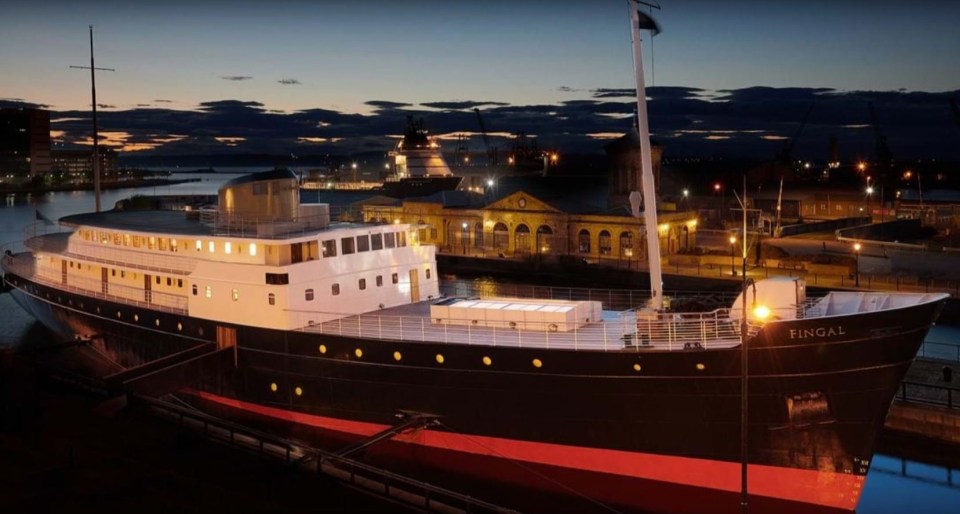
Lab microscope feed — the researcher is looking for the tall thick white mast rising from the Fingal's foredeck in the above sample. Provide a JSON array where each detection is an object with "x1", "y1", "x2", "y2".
[{"x1": 627, "y1": 0, "x2": 663, "y2": 310}]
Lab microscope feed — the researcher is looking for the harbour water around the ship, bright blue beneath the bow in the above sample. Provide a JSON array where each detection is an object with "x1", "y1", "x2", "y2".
[{"x1": 0, "y1": 175, "x2": 960, "y2": 508}]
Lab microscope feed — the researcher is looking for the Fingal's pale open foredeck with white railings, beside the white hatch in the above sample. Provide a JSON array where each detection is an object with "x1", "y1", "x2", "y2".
[{"x1": 302, "y1": 302, "x2": 740, "y2": 351}]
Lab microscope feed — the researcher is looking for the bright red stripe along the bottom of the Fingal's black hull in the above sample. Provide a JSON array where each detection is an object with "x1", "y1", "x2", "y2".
[{"x1": 190, "y1": 391, "x2": 865, "y2": 510}]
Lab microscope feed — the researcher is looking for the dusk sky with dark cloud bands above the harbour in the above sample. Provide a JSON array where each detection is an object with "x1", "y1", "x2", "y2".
[{"x1": 0, "y1": 0, "x2": 960, "y2": 158}]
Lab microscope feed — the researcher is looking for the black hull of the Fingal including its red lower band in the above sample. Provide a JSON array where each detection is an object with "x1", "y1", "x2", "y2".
[{"x1": 1, "y1": 270, "x2": 942, "y2": 512}]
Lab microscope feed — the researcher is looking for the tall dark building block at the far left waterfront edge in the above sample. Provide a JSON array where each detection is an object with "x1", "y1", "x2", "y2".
[{"x1": 0, "y1": 107, "x2": 50, "y2": 179}]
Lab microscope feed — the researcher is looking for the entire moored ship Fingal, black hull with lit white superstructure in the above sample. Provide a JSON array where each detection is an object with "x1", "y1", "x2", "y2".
[{"x1": 2, "y1": 4, "x2": 947, "y2": 514}]
